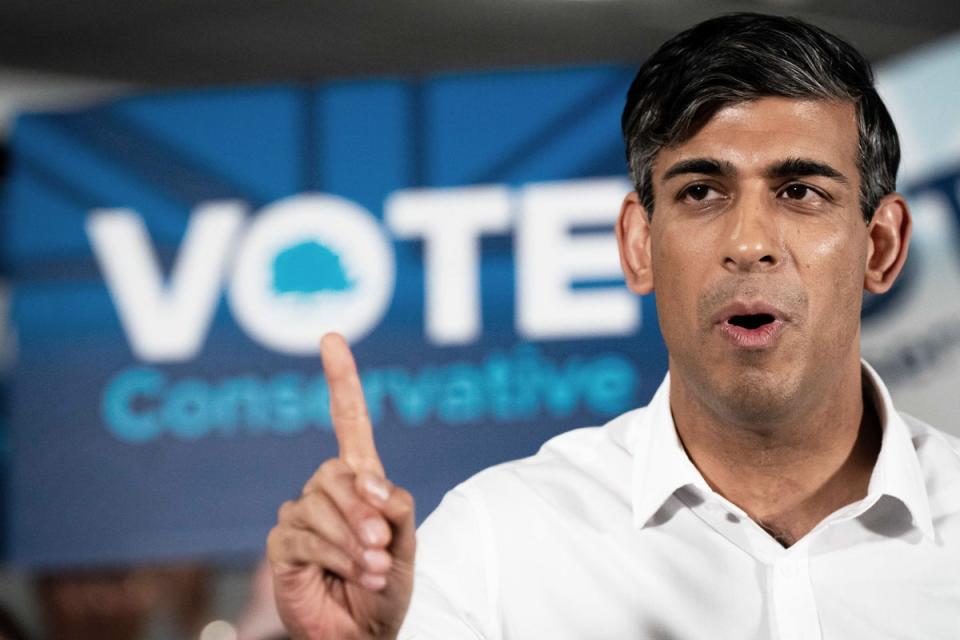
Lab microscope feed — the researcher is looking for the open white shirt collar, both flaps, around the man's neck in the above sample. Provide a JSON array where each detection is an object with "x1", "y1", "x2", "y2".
[{"x1": 629, "y1": 361, "x2": 933, "y2": 538}]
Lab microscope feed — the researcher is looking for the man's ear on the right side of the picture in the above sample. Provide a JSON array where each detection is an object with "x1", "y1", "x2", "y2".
[{"x1": 863, "y1": 193, "x2": 912, "y2": 293}]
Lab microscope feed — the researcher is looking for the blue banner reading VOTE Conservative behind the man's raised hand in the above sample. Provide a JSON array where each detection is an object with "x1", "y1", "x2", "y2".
[{"x1": 2, "y1": 67, "x2": 666, "y2": 567}]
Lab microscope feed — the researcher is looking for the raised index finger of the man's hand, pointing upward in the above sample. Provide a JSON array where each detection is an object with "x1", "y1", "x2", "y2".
[{"x1": 320, "y1": 333, "x2": 384, "y2": 478}]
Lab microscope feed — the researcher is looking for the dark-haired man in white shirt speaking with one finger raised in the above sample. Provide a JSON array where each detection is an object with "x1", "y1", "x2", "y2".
[{"x1": 268, "y1": 14, "x2": 960, "y2": 640}]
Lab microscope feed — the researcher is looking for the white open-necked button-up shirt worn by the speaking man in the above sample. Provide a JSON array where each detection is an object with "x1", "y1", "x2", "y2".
[{"x1": 400, "y1": 364, "x2": 960, "y2": 640}]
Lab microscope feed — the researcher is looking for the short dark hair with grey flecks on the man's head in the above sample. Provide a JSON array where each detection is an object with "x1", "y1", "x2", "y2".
[{"x1": 621, "y1": 13, "x2": 900, "y2": 222}]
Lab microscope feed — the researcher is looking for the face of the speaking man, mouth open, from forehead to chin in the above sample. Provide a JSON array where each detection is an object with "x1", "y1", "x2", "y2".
[{"x1": 636, "y1": 98, "x2": 869, "y2": 423}]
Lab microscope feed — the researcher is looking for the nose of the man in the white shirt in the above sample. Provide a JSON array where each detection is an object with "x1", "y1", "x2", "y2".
[{"x1": 720, "y1": 193, "x2": 786, "y2": 271}]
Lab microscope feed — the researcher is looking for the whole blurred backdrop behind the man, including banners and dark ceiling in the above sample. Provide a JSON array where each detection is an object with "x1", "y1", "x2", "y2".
[{"x1": 0, "y1": 0, "x2": 960, "y2": 640}]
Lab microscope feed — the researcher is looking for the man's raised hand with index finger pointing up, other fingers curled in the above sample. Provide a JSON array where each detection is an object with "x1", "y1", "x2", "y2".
[{"x1": 267, "y1": 333, "x2": 416, "y2": 640}]
